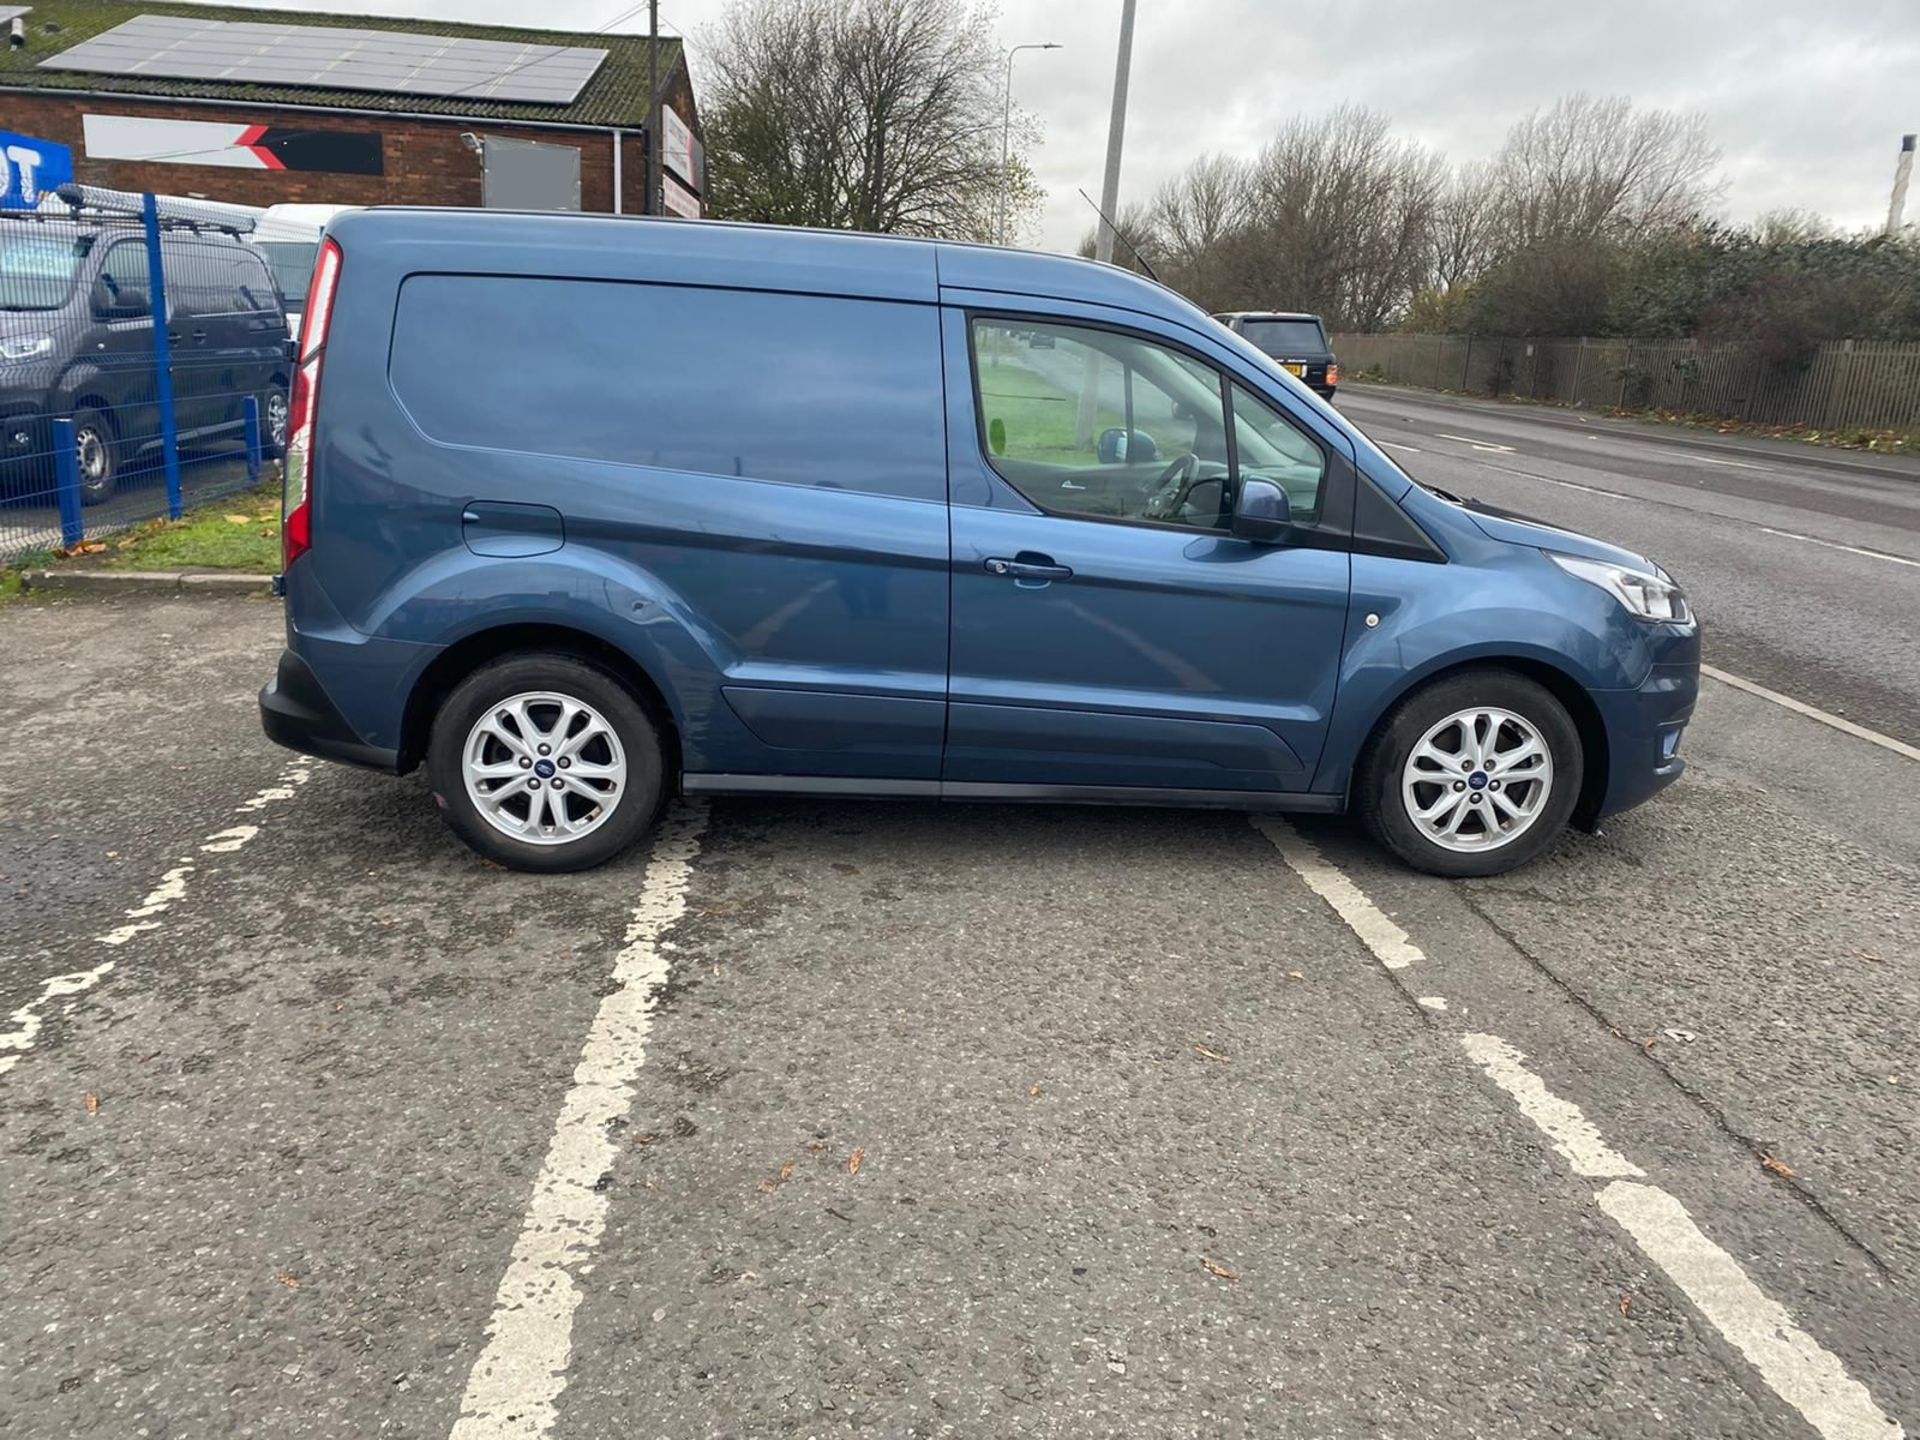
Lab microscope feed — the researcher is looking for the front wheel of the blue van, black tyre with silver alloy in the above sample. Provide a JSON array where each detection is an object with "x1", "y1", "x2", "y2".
[{"x1": 1354, "y1": 670, "x2": 1586, "y2": 877}]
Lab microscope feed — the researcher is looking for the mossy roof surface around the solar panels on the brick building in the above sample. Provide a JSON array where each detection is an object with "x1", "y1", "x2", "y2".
[{"x1": 0, "y1": 0, "x2": 680, "y2": 127}]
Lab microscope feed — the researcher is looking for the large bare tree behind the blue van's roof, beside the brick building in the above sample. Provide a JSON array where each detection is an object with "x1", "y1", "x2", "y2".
[{"x1": 705, "y1": 0, "x2": 1039, "y2": 240}]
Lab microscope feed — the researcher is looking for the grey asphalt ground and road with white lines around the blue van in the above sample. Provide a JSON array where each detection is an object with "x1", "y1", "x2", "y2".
[{"x1": 0, "y1": 392, "x2": 1920, "y2": 1440}]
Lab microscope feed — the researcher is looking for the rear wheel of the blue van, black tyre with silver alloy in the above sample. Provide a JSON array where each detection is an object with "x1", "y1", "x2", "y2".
[{"x1": 426, "y1": 655, "x2": 666, "y2": 874}]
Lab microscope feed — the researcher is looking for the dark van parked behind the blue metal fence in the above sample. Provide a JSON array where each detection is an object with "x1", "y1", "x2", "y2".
[{"x1": 0, "y1": 213, "x2": 292, "y2": 505}]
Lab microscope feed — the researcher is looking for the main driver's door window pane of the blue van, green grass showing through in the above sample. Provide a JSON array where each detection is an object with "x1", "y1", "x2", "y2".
[{"x1": 973, "y1": 319, "x2": 1233, "y2": 530}]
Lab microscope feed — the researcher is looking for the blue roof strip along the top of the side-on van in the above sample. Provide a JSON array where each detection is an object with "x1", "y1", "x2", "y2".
[{"x1": 328, "y1": 205, "x2": 1206, "y2": 326}]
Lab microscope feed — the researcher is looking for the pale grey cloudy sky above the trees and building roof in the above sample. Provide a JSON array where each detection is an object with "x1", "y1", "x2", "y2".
[{"x1": 217, "y1": 0, "x2": 1920, "y2": 250}]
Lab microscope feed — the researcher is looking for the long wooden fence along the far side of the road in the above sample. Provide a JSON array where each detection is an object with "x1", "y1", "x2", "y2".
[{"x1": 1332, "y1": 334, "x2": 1920, "y2": 430}]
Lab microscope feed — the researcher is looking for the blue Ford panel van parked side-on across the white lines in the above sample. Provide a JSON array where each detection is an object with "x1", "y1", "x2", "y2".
[{"x1": 261, "y1": 209, "x2": 1699, "y2": 876}]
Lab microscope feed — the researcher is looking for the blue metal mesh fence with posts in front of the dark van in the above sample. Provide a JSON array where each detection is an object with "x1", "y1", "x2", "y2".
[{"x1": 0, "y1": 192, "x2": 294, "y2": 564}]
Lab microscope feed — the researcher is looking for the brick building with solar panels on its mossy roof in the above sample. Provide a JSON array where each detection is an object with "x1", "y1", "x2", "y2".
[{"x1": 0, "y1": 0, "x2": 703, "y2": 215}]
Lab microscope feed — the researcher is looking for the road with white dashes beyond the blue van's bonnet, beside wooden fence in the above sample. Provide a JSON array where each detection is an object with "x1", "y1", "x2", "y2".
[{"x1": 1338, "y1": 386, "x2": 1920, "y2": 745}]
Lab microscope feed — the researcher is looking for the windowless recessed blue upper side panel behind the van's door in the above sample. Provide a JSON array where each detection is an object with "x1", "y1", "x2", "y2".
[{"x1": 390, "y1": 275, "x2": 947, "y2": 499}]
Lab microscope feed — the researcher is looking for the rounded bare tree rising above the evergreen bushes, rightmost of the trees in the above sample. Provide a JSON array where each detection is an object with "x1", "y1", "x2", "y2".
[{"x1": 1494, "y1": 94, "x2": 1720, "y2": 250}]
